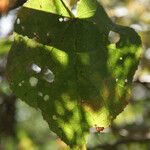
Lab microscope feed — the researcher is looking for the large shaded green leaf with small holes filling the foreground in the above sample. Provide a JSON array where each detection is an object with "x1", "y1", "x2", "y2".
[{"x1": 7, "y1": 0, "x2": 141, "y2": 147}]
